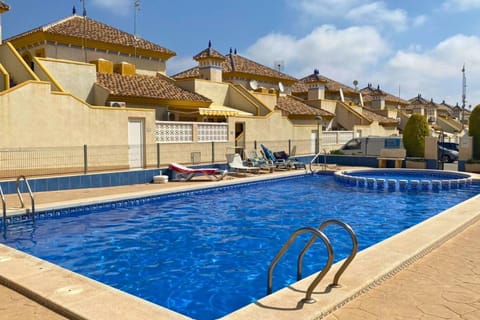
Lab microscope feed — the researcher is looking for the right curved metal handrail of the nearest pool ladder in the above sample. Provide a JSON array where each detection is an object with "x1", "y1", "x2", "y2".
[{"x1": 297, "y1": 219, "x2": 358, "y2": 286}]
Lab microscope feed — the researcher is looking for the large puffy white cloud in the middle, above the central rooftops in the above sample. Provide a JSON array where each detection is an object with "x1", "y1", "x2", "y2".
[{"x1": 247, "y1": 25, "x2": 389, "y2": 83}]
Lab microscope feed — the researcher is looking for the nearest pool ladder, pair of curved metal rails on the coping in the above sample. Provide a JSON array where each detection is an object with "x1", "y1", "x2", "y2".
[{"x1": 267, "y1": 219, "x2": 358, "y2": 303}]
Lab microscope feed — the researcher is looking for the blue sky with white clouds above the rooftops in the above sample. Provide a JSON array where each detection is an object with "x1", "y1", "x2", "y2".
[{"x1": 2, "y1": 0, "x2": 480, "y2": 106}]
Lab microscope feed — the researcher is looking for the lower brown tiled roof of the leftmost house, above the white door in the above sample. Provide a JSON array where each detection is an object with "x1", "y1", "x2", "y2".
[{"x1": 97, "y1": 73, "x2": 211, "y2": 102}]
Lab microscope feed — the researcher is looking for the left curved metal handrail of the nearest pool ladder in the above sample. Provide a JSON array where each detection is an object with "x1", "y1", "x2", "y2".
[{"x1": 267, "y1": 227, "x2": 333, "y2": 303}]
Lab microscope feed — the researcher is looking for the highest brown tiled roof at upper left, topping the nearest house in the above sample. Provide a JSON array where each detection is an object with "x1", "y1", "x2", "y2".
[{"x1": 5, "y1": 15, "x2": 175, "y2": 57}]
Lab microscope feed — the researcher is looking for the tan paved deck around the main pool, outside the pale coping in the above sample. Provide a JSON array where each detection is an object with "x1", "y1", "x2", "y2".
[{"x1": 0, "y1": 169, "x2": 480, "y2": 320}]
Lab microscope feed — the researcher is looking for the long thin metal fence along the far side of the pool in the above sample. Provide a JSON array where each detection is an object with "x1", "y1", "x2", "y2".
[{"x1": 0, "y1": 136, "x2": 348, "y2": 179}]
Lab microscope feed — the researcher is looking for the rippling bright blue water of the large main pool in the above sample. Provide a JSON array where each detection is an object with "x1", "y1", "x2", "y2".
[{"x1": 1, "y1": 175, "x2": 480, "y2": 319}]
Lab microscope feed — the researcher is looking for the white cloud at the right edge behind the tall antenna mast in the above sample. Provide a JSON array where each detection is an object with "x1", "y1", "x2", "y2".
[{"x1": 374, "y1": 35, "x2": 480, "y2": 105}]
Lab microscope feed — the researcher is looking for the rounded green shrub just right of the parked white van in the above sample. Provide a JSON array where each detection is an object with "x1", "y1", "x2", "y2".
[{"x1": 403, "y1": 113, "x2": 429, "y2": 158}]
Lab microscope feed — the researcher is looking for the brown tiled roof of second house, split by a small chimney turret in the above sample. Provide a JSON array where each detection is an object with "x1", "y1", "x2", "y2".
[{"x1": 172, "y1": 49, "x2": 297, "y2": 82}]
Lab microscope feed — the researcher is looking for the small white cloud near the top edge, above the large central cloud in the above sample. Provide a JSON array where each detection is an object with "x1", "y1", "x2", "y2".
[{"x1": 345, "y1": 2, "x2": 408, "y2": 31}]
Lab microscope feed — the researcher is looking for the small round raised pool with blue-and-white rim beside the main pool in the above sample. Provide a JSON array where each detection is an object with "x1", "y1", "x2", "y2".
[{"x1": 335, "y1": 169, "x2": 472, "y2": 192}]
